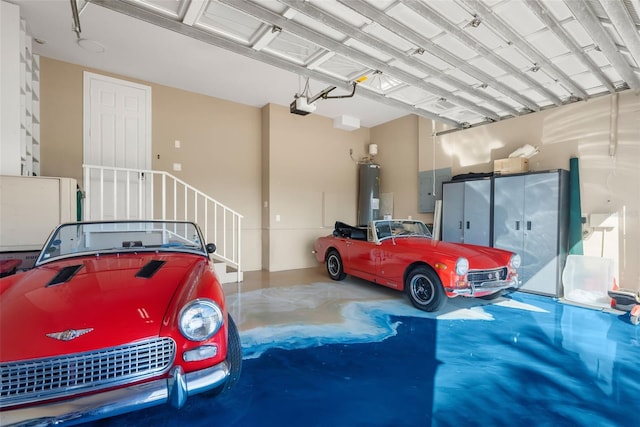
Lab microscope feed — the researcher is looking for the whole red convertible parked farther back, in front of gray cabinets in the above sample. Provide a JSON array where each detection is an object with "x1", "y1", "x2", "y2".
[{"x1": 313, "y1": 220, "x2": 520, "y2": 311}]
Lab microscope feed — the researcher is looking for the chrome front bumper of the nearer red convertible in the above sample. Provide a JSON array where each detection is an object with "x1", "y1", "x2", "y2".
[{"x1": 0, "y1": 362, "x2": 229, "y2": 427}]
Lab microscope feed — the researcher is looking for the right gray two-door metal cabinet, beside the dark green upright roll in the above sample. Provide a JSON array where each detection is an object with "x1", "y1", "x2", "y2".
[{"x1": 493, "y1": 170, "x2": 569, "y2": 297}]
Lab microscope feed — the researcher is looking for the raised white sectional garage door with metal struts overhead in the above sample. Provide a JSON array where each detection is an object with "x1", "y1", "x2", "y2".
[{"x1": 42, "y1": 0, "x2": 640, "y2": 128}]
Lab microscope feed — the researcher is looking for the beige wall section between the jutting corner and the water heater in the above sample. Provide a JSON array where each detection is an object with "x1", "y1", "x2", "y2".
[{"x1": 263, "y1": 105, "x2": 370, "y2": 271}]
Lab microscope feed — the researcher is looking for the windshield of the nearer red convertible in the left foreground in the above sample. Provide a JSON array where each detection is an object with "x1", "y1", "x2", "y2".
[{"x1": 36, "y1": 221, "x2": 207, "y2": 265}]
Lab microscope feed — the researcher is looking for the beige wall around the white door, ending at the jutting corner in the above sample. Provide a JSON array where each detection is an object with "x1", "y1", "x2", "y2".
[{"x1": 40, "y1": 57, "x2": 262, "y2": 271}]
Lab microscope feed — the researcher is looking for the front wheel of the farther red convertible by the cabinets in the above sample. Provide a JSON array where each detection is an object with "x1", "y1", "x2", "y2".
[{"x1": 404, "y1": 267, "x2": 447, "y2": 311}]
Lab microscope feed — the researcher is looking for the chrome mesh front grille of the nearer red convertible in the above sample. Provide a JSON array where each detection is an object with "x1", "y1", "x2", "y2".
[{"x1": 0, "y1": 338, "x2": 176, "y2": 407}]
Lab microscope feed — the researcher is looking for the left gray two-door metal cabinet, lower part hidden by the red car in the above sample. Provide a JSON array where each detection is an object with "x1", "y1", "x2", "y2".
[{"x1": 442, "y1": 178, "x2": 491, "y2": 246}]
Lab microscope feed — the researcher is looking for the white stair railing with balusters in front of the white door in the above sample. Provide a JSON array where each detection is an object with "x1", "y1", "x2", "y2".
[{"x1": 82, "y1": 165, "x2": 242, "y2": 279}]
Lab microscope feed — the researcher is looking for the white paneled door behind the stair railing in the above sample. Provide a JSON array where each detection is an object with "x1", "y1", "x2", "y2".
[{"x1": 83, "y1": 72, "x2": 152, "y2": 220}]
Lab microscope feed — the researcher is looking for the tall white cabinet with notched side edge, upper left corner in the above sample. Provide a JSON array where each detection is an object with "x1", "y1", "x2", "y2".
[{"x1": 0, "y1": 1, "x2": 40, "y2": 176}]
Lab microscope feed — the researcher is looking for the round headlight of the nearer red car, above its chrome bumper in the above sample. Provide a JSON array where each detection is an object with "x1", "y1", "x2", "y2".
[{"x1": 178, "y1": 299, "x2": 223, "y2": 341}]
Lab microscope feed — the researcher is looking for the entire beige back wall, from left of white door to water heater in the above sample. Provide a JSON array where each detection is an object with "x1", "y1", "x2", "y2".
[{"x1": 41, "y1": 57, "x2": 369, "y2": 271}]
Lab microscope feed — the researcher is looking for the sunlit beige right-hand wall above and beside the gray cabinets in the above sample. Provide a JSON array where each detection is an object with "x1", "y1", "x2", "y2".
[{"x1": 371, "y1": 91, "x2": 640, "y2": 289}]
